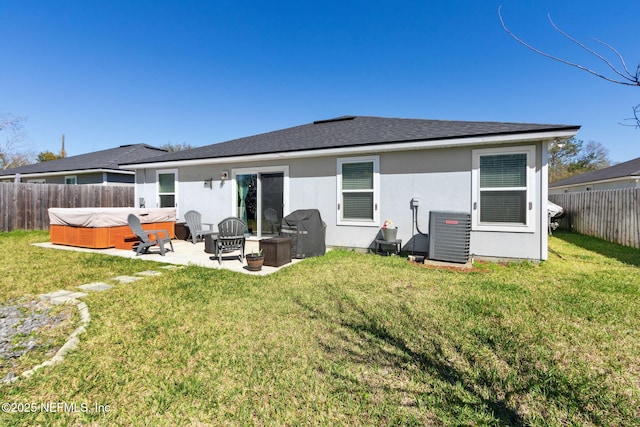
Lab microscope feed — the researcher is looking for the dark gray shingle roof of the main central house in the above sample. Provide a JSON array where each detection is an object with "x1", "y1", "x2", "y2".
[{"x1": 120, "y1": 116, "x2": 580, "y2": 164}]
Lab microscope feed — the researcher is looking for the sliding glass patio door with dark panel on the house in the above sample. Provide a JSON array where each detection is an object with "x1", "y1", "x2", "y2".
[{"x1": 235, "y1": 171, "x2": 285, "y2": 237}]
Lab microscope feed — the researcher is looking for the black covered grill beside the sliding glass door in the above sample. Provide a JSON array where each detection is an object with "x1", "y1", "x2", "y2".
[{"x1": 280, "y1": 209, "x2": 327, "y2": 258}]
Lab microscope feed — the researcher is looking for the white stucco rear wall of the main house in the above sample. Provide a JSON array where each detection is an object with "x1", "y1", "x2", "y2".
[{"x1": 136, "y1": 143, "x2": 547, "y2": 259}]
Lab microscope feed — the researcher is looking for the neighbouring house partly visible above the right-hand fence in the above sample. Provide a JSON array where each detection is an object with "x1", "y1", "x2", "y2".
[{"x1": 549, "y1": 157, "x2": 640, "y2": 194}]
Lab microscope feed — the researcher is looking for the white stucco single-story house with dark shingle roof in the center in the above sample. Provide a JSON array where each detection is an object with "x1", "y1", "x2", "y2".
[{"x1": 121, "y1": 116, "x2": 580, "y2": 260}]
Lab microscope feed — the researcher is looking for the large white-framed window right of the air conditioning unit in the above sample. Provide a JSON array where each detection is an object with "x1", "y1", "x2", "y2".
[{"x1": 471, "y1": 146, "x2": 536, "y2": 233}]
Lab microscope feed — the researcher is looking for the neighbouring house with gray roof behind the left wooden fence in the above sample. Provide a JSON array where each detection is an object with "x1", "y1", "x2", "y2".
[{"x1": 0, "y1": 144, "x2": 167, "y2": 185}]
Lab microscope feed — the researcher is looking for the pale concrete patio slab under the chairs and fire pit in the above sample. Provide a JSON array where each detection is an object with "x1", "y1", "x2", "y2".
[{"x1": 34, "y1": 240, "x2": 302, "y2": 276}]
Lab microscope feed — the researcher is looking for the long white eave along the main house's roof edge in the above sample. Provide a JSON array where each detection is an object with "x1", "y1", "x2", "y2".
[{"x1": 126, "y1": 127, "x2": 580, "y2": 170}]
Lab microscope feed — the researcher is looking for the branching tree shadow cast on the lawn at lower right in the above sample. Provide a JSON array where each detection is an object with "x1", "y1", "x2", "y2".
[{"x1": 297, "y1": 295, "x2": 606, "y2": 426}]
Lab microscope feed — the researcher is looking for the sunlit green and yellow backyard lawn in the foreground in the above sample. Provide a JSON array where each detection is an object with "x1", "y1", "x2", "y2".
[{"x1": 0, "y1": 232, "x2": 640, "y2": 426}]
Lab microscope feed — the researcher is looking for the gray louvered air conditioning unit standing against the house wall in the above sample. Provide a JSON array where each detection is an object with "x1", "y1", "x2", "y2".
[{"x1": 428, "y1": 211, "x2": 471, "y2": 264}]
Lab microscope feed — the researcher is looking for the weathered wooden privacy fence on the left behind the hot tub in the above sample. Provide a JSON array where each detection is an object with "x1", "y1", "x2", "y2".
[{"x1": 0, "y1": 183, "x2": 134, "y2": 231}]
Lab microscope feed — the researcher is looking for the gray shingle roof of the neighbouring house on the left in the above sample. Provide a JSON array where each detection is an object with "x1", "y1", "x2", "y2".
[{"x1": 0, "y1": 144, "x2": 167, "y2": 176}]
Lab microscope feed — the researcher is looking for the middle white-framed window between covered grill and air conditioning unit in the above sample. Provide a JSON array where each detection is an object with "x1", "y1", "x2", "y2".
[{"x1": 337, "y1": 156, "x2": 380, "y2": 227}]
